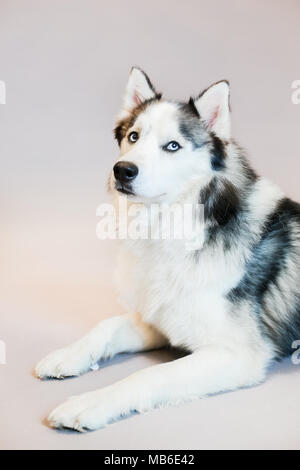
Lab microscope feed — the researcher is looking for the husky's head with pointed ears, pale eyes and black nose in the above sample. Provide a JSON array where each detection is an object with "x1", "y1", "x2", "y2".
[{"x1": 110, "y1": 67, "x2": 230, "y2": 201}]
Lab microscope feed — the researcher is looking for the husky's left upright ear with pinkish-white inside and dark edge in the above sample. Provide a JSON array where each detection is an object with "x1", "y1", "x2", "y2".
[{"x1": 119, "y1": 67, "x2": 159, "y2": 118}]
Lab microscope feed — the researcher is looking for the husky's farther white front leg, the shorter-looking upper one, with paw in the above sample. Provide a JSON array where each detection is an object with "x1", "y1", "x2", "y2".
[{"x1": 35, "y1": 314, "x2": 167, "y2": 378}]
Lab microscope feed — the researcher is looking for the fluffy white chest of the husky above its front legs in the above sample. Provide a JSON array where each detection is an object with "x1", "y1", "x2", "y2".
[{"x1": 118, "y1": 241, "x2": 241, "y2": 350}]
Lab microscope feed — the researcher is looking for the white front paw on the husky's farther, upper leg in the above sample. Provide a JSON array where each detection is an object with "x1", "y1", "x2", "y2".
[{"x1": 35, "y1": 344, "x2": 95, "y2": 379}]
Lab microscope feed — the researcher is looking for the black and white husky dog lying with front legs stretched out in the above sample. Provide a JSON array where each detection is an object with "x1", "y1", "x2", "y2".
[{"x1": 36, "y1": 68, "x2": 300, "y2": 431}]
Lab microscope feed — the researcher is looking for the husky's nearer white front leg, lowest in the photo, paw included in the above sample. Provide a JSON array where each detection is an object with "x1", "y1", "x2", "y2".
[{"x1": 49, "y1": 346, "x2": 266, "y2": 431}]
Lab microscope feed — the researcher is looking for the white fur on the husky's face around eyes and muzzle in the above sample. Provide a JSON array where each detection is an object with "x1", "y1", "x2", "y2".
[{"x1": 111, "y1": 102, "x2": 213, "y2": 202}]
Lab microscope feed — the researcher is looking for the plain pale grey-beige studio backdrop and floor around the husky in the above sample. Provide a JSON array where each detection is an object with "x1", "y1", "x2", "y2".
[{"x1": 0, "y1": 0, "x2": 300, "y2": 449}]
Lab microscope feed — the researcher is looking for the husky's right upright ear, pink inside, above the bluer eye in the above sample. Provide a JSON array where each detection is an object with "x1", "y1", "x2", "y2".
[{"x1": 194, "y1": 80, "x2": 231, "y2": 139}]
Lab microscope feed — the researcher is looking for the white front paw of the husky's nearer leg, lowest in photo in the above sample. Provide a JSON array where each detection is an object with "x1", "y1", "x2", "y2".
[{"x1": 48, "y1": 389, "x2": 122, "y2": 432}]
